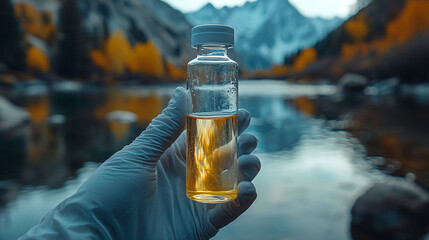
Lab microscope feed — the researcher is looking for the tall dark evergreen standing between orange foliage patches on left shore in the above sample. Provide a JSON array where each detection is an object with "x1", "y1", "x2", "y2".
[{"x1": 56, "y1": 0, "x2": 89, "y2": 78}]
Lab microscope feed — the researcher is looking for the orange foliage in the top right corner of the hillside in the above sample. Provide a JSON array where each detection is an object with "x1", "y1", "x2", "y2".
[{"x1": 386, "y1": 0, "x2": 429, "y2": 43}]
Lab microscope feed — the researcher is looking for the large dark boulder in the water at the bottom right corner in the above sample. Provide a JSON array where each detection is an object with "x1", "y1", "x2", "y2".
[{"x1": 351, "y1": 180, "x2": 429, "y2": 240}]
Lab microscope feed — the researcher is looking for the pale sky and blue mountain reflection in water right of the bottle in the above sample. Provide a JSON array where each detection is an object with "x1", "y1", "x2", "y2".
[{"x1": 215, "y1": 96, "x2": 372, "y2": 239}]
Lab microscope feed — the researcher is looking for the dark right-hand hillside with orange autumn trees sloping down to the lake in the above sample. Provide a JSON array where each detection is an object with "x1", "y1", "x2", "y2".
[{"x1": 285, "y1": 0, "x2": 429, "y2": 82}]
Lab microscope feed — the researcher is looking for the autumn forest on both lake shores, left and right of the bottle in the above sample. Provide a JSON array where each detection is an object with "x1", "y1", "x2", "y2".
[{"x1": 0, "y1": 0, "x2": 429, "y2": 84}]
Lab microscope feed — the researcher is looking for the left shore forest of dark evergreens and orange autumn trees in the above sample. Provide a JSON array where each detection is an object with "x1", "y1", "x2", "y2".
[{"x1": 0, "y1": 0, "x2": 186, "y2": 83}]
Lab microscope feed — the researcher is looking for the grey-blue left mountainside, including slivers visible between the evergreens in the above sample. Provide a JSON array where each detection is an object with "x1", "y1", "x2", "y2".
[{"x1": 13, "y1": 0, "x2": 195, "y2": 71}]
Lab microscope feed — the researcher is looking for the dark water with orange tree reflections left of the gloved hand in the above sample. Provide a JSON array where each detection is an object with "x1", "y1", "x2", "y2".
[{"x1": 0, "y1": 82, "x2": 174, "y2": 202}]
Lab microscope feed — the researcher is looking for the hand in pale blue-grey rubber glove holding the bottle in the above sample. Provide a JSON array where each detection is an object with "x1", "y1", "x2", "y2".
[{"x1": 20, "y1": 87, "x2": 260, "y2": 239}]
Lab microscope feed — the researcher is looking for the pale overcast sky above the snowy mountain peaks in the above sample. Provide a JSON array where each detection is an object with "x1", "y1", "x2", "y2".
[{"x1": 163, "y1": 0, "x2": 356, "y2": 18}]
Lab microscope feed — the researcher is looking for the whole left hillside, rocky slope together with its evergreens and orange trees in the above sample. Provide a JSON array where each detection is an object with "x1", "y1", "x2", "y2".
[{"x1": 0, "y1": 0, "x2": 191, "y2": 78}]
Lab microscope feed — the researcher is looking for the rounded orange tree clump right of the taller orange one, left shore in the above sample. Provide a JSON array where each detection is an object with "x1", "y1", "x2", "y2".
[{"x1": 127, "y1": 41, "x2": 164, "y2": 77}]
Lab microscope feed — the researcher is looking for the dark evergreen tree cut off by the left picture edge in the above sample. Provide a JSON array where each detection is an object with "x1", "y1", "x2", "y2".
[{"x1": 0, "y1": 0, "x2": 25, "y2": 70}]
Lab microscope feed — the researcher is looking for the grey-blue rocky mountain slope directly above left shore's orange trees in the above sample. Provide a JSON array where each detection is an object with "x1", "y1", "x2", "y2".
[{"x1": 79, "y1": 0, "x2": 194, "y2": 66}]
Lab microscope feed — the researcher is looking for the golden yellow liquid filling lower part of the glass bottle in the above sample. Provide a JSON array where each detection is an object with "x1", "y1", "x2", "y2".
[{"x1": 186, "y1": 115, "x2": 238, "y2": 203}]
